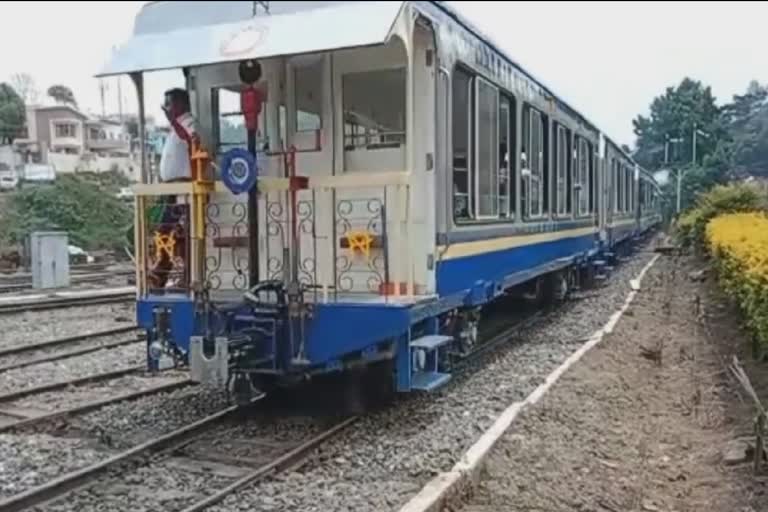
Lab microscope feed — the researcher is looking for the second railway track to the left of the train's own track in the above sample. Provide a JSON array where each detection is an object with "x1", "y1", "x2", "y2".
[{"x1": 0, "y1": 326, "x2": 146, "y2": 373}]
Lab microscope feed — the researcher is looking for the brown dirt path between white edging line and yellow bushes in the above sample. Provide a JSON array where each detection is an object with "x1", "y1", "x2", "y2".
[{"x1": 455, "y1": 253, "x2": 768, "y2": 512}]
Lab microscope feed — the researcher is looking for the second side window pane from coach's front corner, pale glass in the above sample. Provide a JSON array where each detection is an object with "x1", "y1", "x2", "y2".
[{"x1": 475, "y1": 78, "x2": 499, "y2": 219}]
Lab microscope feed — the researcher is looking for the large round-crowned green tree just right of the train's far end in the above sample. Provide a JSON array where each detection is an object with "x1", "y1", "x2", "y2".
[{"x1": 632, "y1": 78, "x2": 726, "y2": 169}]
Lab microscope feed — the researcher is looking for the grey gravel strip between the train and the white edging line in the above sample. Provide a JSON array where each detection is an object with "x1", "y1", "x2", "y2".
[{"x1": 204, "y1": 252, "x2": 652, "y2": 512}]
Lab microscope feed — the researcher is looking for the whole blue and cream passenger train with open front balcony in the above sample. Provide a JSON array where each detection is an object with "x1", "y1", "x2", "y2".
[{"x1": 100, "y1": 1, "x2": 659, "y2": 397}]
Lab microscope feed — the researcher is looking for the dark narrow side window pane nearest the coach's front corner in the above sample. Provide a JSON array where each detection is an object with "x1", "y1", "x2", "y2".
[{"x1": 452, "y1": 68, "x2": 475, "y2": 221}]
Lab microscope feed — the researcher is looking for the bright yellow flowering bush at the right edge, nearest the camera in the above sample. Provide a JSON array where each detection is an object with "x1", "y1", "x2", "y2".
[{"x1": 706, "y1": 212, "x2": 768, "y2": 348}]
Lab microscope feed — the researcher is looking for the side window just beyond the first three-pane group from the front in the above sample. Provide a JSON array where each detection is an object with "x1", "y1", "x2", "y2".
[{"x1": 521, "y1": 105, "x2": 546, "y2": 219}]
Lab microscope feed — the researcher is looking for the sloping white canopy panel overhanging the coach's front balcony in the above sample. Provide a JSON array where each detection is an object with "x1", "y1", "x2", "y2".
[{"x1": 97, "y1": 1, "x2": 403, "y2": 76}]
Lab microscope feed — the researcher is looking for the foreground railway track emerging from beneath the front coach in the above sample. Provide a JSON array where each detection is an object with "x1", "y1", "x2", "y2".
[{"x1": 0, "y1": 400, "x2": 357, "y2": 512}]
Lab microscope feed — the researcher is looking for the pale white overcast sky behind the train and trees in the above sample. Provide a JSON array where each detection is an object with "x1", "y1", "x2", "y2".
[{"x1": 0, "y1": 2, "x2": 768, "y2": 143}]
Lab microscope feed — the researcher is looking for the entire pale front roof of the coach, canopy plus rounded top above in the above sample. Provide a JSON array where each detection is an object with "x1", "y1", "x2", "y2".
[{"x1": 97, "y1": 1, "x2": 403, "y2": 76}]
